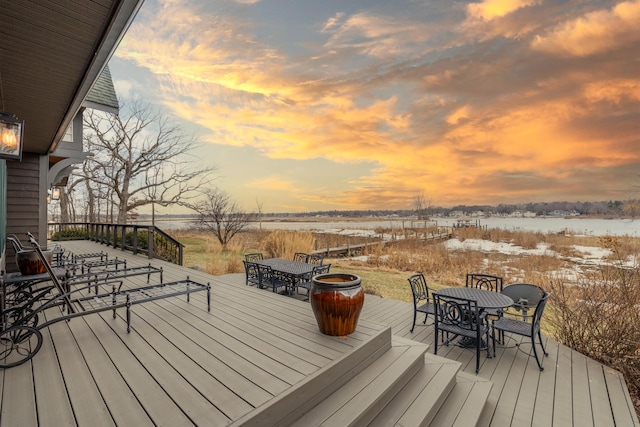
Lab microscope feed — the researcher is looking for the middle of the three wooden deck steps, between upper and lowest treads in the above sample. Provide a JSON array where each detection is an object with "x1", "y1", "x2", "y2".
[{"x1": 370, "y1": 354, "x2": 461, "y2": 427}]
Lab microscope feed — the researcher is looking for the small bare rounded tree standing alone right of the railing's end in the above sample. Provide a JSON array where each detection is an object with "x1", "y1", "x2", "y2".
[{"x1": 191, "y1": 187, "x2": 256, "y2": 250}]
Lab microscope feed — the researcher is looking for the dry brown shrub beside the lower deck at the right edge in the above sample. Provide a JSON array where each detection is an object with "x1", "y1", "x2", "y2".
[{"x1": 545, "y1": 237, "x2": 640, "y2": 409}]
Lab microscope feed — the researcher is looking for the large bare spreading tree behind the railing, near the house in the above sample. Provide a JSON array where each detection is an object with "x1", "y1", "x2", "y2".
[{"x1": 83, "y1": 101, "x2": 216, "y2": 223}]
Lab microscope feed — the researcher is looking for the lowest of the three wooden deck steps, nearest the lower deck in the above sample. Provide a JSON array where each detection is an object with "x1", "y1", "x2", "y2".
[{"x1": 429, "y1": 372, "x2": 493, "y2": 427}]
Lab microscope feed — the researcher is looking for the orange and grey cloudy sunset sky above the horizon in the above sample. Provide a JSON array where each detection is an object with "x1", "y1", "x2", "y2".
[{"x1": 110, "y1": 0, "x2": 640, "y2": 212}]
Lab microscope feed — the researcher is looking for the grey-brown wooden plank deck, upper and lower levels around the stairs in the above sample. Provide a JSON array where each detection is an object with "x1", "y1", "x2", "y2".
[{"x1": 0, "y1": 241, "x2": 640, "y2": 426}]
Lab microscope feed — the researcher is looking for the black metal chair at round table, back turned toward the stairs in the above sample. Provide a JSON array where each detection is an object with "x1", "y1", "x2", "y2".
[{"x1": 433, "y1": 292, "x2": 491, "y2": 374}]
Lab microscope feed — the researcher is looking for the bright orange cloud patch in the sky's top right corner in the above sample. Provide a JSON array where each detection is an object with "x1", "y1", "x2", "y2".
[{"x1": 531, "y1": 0, "x2": 640, "y2": 56}]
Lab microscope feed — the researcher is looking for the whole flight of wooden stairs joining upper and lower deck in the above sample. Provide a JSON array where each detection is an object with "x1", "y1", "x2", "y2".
[{"x1": 234, "y1": 331, "x2": 492, "y2": 427}]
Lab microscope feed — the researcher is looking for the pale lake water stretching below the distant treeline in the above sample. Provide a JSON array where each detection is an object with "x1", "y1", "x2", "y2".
[{"x1": 145, "y1": 217, "x2": 640, "y2": 237}]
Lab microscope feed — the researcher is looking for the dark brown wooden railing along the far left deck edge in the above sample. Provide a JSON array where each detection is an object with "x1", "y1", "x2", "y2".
[{"x1": 47, "y1": 222, "x2": 184, "y2": 265}]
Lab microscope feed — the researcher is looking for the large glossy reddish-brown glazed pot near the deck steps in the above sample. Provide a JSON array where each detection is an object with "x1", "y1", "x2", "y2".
[{"x1": 309, "y1": 273, "x2": 364, "y2": 336}]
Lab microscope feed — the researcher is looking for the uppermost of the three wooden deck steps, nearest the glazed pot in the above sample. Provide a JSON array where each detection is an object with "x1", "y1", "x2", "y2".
[{"x1": 293, "y1": 337, "x2": 428, "y2": 427}]
